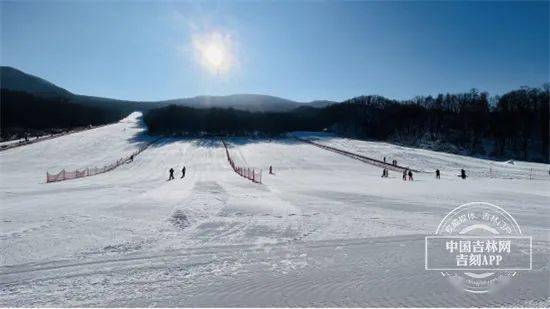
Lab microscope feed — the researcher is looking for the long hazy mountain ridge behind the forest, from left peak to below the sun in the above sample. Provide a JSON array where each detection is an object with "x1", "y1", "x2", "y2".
[{"x1": 0, "y1": 66, "x2": 336, "y2": 112}]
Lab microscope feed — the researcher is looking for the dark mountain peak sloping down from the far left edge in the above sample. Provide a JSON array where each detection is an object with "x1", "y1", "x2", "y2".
[{"x1": 0, "y1": 66, "x2": 72, "y2": 96}]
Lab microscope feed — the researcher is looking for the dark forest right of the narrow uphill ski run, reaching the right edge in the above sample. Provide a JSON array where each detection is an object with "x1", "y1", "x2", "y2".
[{"x1": 144, "y1": 84, "x2": 550, "y2": 162}]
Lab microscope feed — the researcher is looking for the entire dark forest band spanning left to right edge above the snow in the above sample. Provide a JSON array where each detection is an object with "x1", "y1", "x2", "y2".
[{"x1": 0, "y1": 77, "x2": 550, "y2": 162}]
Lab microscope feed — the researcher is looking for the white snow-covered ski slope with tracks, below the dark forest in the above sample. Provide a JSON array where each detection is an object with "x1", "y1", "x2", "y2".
[{"x1": 0, "y1": 113, "x2": 550, "y2": 307}]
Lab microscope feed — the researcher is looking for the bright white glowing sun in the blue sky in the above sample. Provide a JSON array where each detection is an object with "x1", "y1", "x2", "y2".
[{"x1": 193, "y1": 32, "x2": 234, "y2": 75}]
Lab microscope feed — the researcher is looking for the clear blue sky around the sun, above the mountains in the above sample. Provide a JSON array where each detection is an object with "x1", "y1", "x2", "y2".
[{"x1": 1, "y1": 1, "x2": 550, "y2": 101}]
